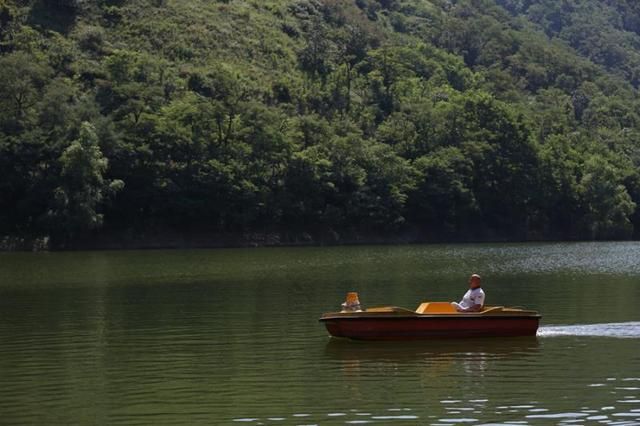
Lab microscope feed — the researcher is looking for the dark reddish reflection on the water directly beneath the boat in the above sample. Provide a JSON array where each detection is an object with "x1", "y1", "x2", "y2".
[{"x1": 325, "y1": 337, "x2": 539, "y2": 362}]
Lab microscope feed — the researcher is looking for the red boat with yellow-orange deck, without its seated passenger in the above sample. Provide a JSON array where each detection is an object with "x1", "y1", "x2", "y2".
[{"x1": 320, "y1": 302, "x2": 541, "y2": 340}]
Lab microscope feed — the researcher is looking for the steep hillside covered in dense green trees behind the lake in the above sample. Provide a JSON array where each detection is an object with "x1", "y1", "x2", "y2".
[{"x1": 0, "y1": 0, "x2": 640, "y2": 247}]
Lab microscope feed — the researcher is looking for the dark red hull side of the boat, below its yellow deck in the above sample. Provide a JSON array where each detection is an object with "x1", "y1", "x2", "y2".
[{"x1": 320, "y1": 313, "x2": 540, "y2": 340}]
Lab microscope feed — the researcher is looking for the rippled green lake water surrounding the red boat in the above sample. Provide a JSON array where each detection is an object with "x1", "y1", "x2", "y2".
[{"x1": 0, "y1": 243, "x2": 640, "y2": 425}]
